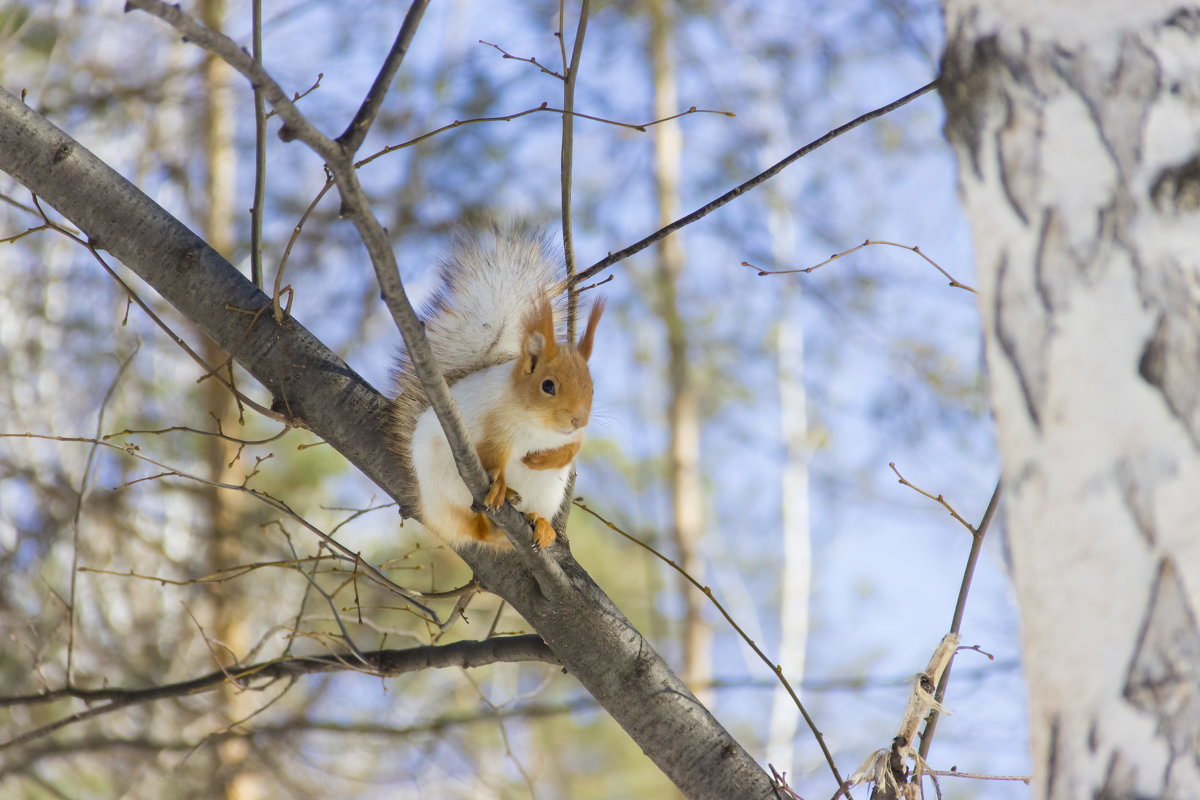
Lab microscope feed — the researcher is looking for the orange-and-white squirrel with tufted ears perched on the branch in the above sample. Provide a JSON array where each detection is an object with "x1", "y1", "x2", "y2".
[{"x1": 390, "y1": 223, "x2": 605, "y2": 548}]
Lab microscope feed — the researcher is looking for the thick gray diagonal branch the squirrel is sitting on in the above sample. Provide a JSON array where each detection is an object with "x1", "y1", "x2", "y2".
[{"x1": 0, "y1": 89, "x2": 774, "y2": 800}]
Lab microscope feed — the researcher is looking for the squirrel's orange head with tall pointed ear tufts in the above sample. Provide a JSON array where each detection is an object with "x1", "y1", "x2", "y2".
[{"x1": 512, "y1": 297, "x2": 604, "y2": 434}]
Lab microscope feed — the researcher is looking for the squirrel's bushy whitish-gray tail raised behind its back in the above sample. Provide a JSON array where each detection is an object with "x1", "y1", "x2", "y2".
[{"x1": 390, "y1": 223, "x2": 564, "y2": 516}]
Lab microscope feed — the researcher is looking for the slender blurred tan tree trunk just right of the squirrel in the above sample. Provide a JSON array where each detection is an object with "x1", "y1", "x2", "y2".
[{"x1": 650, "y1": 0, "x2": 713, "y2": 699}]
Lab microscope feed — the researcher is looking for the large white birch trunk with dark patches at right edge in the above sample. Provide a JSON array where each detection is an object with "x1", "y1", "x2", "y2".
[{"x1": 942, "y1": 0, "x2": 1200, "y2": 798}]
